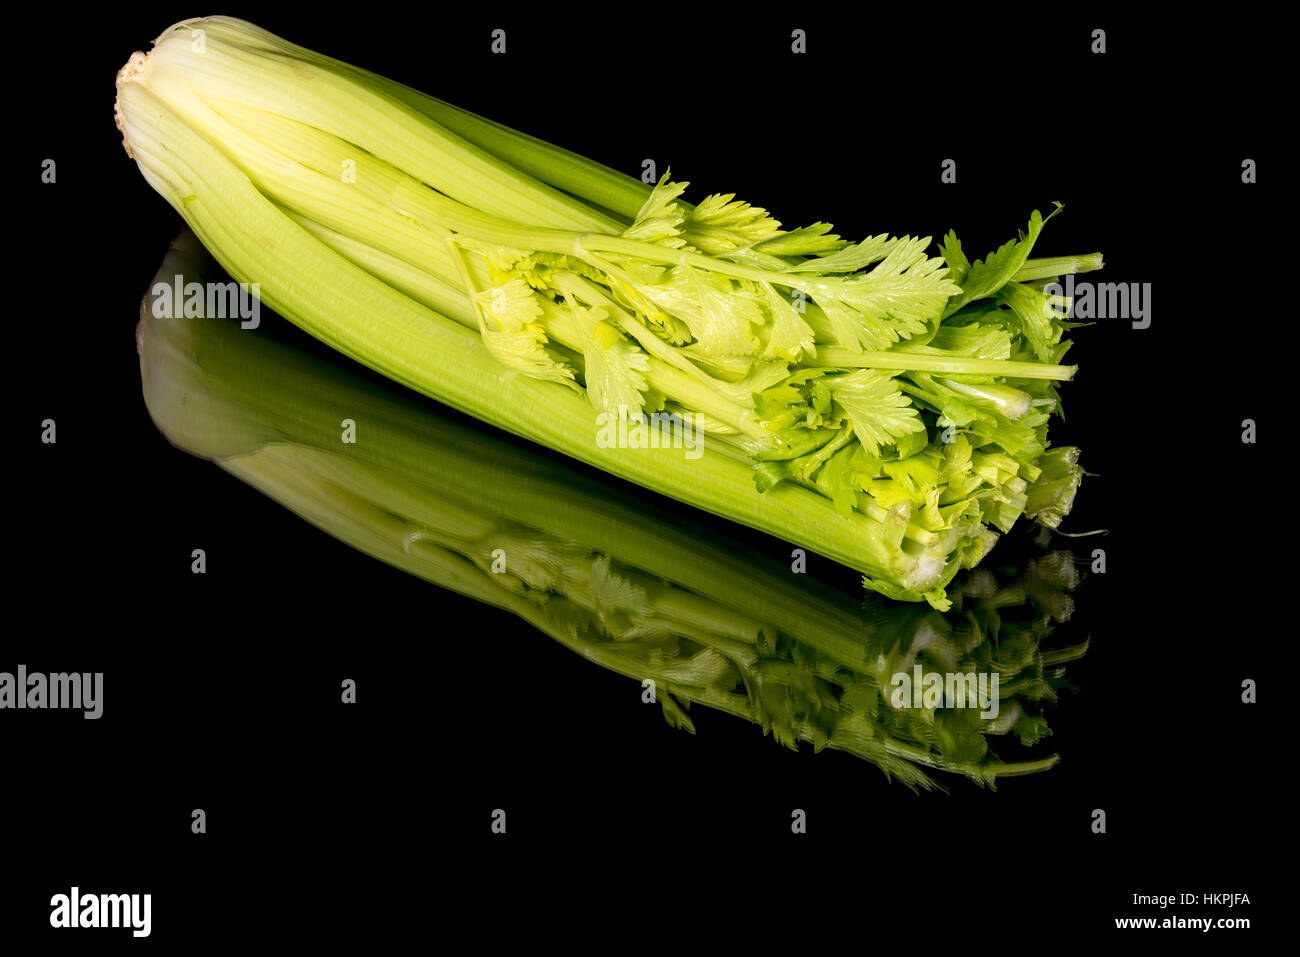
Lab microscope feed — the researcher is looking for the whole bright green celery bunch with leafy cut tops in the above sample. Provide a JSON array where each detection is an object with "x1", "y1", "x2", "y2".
[{"x1": 117, "y1": 17, "x2": 1101, "y2": 609}]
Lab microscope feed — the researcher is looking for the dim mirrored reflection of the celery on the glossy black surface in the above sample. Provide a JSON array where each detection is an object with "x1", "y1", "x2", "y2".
[{"x1": 138, "y1": 234, "x2": 1083, "y2": 788}]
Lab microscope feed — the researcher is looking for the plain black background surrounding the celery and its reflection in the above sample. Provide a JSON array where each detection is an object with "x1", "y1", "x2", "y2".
[{"x1": 0, "y1": 5, "x2": 1294, "y2": 953}]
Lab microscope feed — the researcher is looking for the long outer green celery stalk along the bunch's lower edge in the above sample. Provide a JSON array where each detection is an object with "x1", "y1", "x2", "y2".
[{"x1": 118, "y1": 50, "x2": 967, "y2": 599}]
